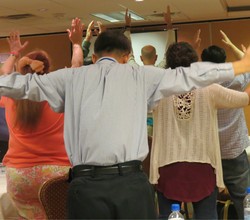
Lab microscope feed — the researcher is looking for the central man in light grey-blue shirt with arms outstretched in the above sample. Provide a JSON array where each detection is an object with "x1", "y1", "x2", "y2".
[{"x1": 0, "y1": 30, "x2": 250, "y2": 219}]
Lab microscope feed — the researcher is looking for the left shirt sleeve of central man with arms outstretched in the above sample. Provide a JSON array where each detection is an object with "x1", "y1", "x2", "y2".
[{"x1": 0, "y1": 68, "x2": 70, "y2": 112}]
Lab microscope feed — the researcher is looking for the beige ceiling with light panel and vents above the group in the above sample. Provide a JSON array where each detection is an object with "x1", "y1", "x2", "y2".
[{"x1": 0, "y1": 0, "x2": 250, "y2": 37}]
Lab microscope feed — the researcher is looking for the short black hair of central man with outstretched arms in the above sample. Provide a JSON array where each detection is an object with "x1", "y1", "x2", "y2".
[{"x1": 94, "y1": 30, "x2": 131, "y2": 55}]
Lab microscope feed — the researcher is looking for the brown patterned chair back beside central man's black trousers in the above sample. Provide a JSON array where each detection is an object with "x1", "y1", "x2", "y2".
[{"x1": 39, "y1": 175, "x2": 69, "y2": 219}]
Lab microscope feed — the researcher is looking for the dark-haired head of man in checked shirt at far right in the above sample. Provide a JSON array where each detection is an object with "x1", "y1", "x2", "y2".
[{"x1": 201, "y1": 45, "x2": 227, "y2": 63}]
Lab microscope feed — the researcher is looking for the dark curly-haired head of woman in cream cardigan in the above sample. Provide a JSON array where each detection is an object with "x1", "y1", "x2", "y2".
[{"x1": 166, "y1": 42, "x2": 198, "y2": 69}]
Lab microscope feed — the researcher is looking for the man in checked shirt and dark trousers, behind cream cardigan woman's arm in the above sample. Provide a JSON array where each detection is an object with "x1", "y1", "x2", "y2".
[{"x1": 201, "y1": 45, "x2": 250, "y2": 219}]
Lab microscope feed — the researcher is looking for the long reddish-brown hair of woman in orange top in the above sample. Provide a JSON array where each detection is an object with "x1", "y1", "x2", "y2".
[{"x1": 15, "y1": 50, "x2": 50, "y2": 131}]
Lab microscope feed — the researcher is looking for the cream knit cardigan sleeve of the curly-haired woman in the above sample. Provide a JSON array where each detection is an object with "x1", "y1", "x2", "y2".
[{"x1": 209, "y1": 84, "x2": 249, "y2": 109}]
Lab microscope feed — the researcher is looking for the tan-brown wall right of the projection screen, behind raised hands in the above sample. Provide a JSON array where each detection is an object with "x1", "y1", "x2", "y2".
[{"x1": 175, "y1": 20, "x2": 250, "y2": 134}]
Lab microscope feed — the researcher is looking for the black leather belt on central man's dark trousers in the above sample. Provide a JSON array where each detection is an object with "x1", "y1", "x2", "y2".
[{"x1": 70, "y1": 160, "x2": 142, "y2": 179}]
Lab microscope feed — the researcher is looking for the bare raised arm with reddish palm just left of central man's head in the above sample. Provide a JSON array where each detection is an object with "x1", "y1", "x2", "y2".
[{"x1": 67, "y1": 18, "x2": 84, "y2": 67}]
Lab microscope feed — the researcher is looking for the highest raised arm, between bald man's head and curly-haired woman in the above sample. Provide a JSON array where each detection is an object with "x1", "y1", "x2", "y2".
[{"x1": 157, "y1": 5, "x2": 176, "y2": 68}]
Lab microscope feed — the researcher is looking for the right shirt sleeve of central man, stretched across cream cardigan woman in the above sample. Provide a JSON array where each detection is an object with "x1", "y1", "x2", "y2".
[{"x1": 144, "y1": 62, "x2": 234, "y2": 109}]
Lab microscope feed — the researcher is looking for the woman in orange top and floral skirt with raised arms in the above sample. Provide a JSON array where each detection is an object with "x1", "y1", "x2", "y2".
[{"x1": 1, "y1": 19, "x2": 83, "y2": 219}]
